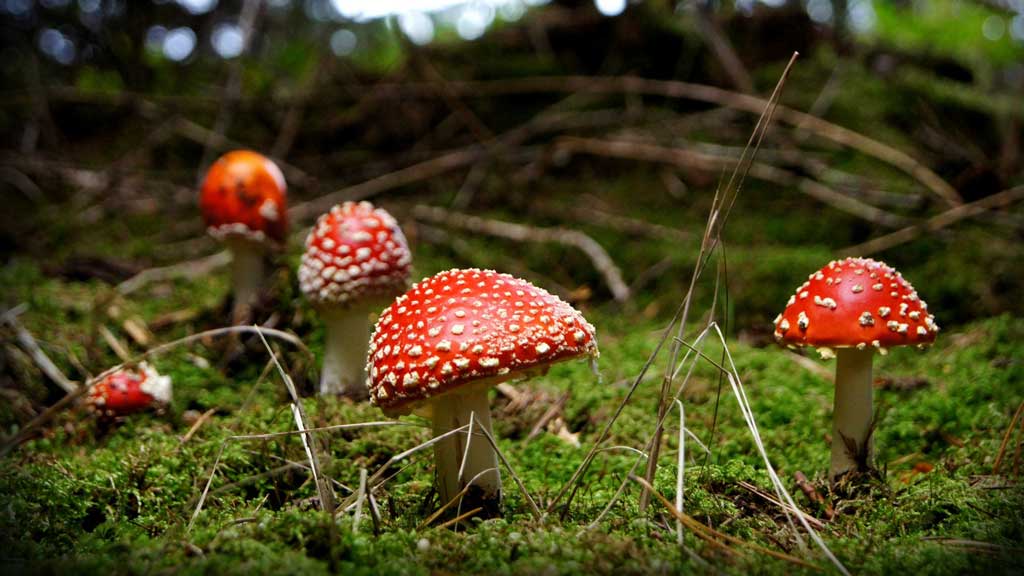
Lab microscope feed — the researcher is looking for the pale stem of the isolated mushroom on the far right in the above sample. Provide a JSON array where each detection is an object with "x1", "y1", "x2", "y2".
[{"x1": 828, "y1": 348, "x2": 874, "y2": 483}]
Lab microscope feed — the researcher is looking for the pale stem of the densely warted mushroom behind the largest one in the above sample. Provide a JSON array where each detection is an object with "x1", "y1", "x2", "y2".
[{"x1": 319, "y1": 306, "x2": 370, "y2": 400}]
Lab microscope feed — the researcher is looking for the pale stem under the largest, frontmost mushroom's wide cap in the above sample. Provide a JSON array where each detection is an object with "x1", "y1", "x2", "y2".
[{"x1": 432, "y1": 386, "x2": 502, "y2": 518}]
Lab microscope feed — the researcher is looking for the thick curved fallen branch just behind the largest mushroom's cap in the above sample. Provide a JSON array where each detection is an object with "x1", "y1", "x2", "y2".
[{"x1": 413, "y1": 204, "x2": 630, "y2": 302}]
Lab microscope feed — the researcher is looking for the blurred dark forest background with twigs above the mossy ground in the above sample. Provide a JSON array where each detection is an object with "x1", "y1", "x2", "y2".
[{"x1": 0, "y1": 0, "x2": 1024, "y2": 332}]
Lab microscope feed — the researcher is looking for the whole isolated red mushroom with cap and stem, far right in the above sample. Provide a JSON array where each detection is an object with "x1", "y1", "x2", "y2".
[{"x1": 775, "y1": 258, "x2": 939, "y2": 483}]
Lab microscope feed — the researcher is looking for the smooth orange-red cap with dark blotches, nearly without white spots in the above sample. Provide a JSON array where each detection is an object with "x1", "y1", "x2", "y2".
[{"x1": 199, "y1": 150, "x2": 288, "y2": 245}]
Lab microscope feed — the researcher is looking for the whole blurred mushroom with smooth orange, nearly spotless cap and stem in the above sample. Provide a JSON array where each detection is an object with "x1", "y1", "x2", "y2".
[{"x1": 199, "y1": 150, "x2": 288, "y2": 323}]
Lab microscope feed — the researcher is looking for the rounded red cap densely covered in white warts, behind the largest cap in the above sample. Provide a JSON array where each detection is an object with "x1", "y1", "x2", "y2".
[{"x1": 299, "y1": 202, "x2": 413, "y2": 307}]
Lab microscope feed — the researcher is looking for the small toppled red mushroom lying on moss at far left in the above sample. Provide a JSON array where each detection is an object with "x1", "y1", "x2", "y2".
[{"x1": 86, "y1": 362, "x2": 171, "y2": 418}]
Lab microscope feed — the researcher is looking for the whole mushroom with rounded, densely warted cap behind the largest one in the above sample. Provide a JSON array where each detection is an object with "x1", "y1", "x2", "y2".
[{"x1": 299, "y1": 202, "x2": 412, "y2": 393}]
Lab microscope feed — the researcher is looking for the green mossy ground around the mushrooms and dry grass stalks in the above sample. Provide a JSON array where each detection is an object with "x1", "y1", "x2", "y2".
[{"x1": 0, "y1": 172, "x2": 1024, "y2": 574}]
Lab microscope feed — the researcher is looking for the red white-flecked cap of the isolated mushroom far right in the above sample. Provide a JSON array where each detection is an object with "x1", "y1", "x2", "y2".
[{"x1": 775, "y1": 258, "x2": 939, "y2": 358}]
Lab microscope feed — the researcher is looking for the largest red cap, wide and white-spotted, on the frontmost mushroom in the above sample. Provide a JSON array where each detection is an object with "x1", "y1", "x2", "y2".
[{"x1": 367, "y1": 269, "x2": 598, "y2": 414}]
